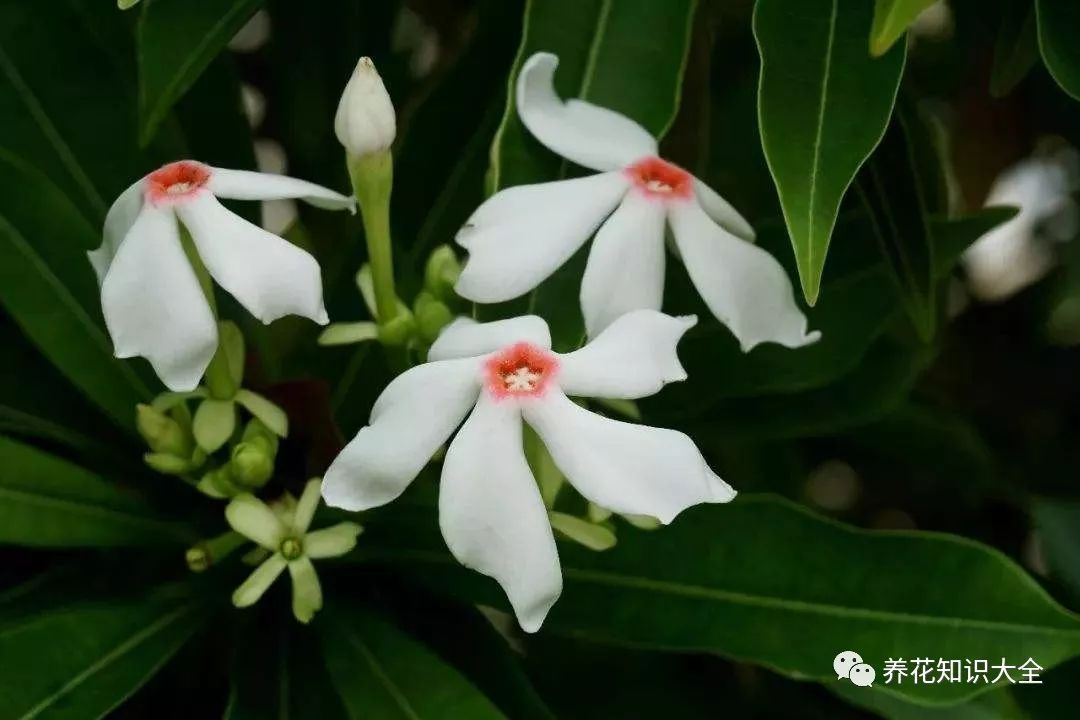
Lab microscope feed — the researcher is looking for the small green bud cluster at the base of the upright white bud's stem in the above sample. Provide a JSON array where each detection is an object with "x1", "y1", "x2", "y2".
[{"x1": 319, "y1": 245, "x2": 461, "y2": 351}]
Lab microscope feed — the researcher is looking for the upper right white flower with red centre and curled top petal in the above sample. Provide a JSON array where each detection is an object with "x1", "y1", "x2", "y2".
[{"x1": 456, "y1": 53, "x2": 820, "y2": 350}]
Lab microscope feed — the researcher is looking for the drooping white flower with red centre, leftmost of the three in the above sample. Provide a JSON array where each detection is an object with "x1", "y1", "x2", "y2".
[{"x1": 90, "y1": 160, "x2": 354, "y2": 391}]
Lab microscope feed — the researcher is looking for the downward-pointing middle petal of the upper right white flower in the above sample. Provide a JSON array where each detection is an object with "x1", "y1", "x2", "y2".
[{"x1": 581, "y1": 192, "x2": 665, "y2": 338}]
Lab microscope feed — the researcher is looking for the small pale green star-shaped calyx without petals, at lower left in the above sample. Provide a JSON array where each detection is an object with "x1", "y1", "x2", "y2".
[{"x1": 225, "y1": 480, "x2": 361, "y2": 623}]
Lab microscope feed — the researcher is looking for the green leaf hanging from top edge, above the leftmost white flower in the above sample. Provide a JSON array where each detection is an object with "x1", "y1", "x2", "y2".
[{"x1": 136, "y1": 0, "x2": 262, "y2": 146}]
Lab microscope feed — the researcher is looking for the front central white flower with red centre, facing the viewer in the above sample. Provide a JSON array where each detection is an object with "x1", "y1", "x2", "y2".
[{"x1": 323, "y1": 310, "x2": 735, "y2": 633}]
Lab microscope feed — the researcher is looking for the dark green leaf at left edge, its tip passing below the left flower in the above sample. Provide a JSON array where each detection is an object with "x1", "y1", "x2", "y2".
[{"x1": 0, "y1": 152, "x2": 150, "y2": 429}]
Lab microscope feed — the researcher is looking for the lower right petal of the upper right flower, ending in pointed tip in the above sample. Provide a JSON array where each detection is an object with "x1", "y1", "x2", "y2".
[{"x1": 669, "y1": 202, "x2": 821, "y2": 352}]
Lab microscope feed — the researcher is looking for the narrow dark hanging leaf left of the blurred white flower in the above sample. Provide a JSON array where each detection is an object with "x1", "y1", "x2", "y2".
[{"x1": 855, "y1": 106, "x2": 937, "y2": 342}]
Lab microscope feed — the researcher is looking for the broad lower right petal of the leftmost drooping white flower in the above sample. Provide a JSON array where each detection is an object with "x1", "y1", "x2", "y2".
[{"x1": 176, "y1": 192, "x2": 328, "y2": 325}]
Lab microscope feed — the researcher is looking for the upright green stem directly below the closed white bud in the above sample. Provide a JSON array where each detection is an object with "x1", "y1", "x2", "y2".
[{"x1": 347, "y1": 150, "x2": 397, "y2": 325}]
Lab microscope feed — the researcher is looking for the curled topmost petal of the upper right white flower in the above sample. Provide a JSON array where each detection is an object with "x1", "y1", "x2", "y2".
[{"x1": 516, "y1": 53, "x2": 657, "y2": 171}]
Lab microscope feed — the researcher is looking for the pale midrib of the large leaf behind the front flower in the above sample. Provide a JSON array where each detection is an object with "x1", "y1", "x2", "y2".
[{"x1": 369, "y1": 551, "x2": 1080, "y2": 639}]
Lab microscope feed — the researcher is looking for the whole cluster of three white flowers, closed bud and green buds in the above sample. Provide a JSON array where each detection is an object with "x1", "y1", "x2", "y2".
[{"x1": 90, "y1": 53, "x2": 820, "y2": 631}]
